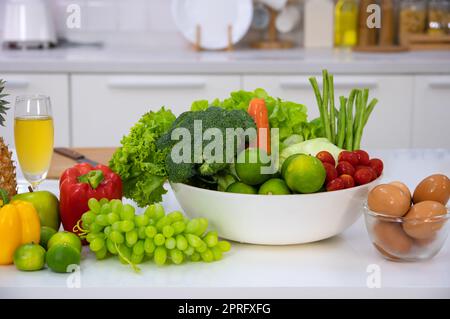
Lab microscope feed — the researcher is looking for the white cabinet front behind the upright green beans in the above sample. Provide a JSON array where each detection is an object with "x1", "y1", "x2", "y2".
[{"x1": 243, "y1": 75, "x2": 414, "y2": 148}]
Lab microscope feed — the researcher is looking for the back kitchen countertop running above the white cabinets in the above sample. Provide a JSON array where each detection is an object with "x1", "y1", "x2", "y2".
[{"x1": 0, "y1": 46, "x2": 450, "y2": 74}]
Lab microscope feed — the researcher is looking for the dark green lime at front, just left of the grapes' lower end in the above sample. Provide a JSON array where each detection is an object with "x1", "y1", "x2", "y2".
[{"x1": 47, "y1": 244, "x2": 81, "y2": 272}]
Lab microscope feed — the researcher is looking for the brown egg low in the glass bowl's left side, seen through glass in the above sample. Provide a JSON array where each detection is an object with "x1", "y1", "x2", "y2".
[{"x1": 373, "y1": 221, "x2": 413, "y2": 258}]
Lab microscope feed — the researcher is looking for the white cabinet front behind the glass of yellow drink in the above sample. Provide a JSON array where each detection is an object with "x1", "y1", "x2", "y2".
[{"x1": 0, "y1": 73, "x2": 70, "y2": 148}]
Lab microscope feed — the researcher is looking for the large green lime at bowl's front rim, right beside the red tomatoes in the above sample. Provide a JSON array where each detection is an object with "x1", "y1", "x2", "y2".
[{"x1": 283, "y1": 154, "x2": 326, "y2": 193}]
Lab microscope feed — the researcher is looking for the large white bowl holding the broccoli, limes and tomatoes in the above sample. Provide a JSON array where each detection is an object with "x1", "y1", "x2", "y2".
[{"x1": 170, "y1": 178, "x2": 381, "y2": 245}]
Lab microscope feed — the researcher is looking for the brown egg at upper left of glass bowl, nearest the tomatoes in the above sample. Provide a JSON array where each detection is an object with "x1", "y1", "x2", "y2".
[{"x1": 367, "y1": 184, "x2": 411, "y2": 217}]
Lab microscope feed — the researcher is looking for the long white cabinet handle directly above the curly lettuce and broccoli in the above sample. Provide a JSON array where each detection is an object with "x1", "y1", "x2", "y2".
[{"x1": 108, "y1": 77, "x2": 206, "y2": 89}]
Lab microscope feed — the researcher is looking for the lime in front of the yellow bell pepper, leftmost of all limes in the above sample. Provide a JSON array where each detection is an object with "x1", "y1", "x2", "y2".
[{"x1": 14, "y1": 244, "x2": 45, "y2": 271}]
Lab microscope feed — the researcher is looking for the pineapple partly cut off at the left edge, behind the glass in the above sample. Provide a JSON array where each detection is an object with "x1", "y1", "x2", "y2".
[{"x1": 0, "y1": 80, "x2": 17, "y2": 197}]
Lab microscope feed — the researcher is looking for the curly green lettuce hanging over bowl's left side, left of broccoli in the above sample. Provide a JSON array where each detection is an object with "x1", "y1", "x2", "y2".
[{"x1": 109, "y1": 107, "x2": 175, "y2": 207}]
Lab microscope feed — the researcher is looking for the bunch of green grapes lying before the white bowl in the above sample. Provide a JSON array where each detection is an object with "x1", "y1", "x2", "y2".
[{"x1": 81, "y1": 198, "x2": 231, "y2": 270}]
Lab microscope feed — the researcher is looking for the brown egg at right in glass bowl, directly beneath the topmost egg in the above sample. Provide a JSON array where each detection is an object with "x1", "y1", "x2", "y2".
[{"x1": 403, "y1": 200, "x2": 447, "y2": 239}]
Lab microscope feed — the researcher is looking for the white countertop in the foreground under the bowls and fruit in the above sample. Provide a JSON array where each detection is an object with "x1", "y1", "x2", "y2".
[{"x1": 0, "y1": 149, "x2": 450, "y2": 298}]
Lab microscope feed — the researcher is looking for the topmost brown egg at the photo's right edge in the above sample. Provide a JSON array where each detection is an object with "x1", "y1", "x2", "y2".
[{"x1": 413, "y1": 174, "x2": 450, "y2": 206}]
